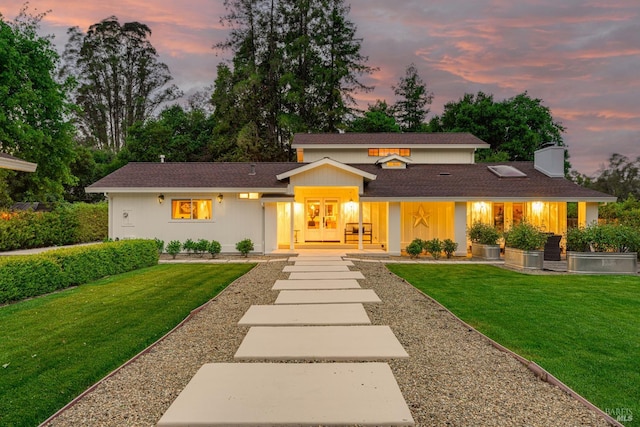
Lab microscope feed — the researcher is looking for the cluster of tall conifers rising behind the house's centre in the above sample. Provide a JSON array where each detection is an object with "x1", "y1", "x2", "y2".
[{"x1": 212, "y1": 0, "x2": 372, "y2": 160}]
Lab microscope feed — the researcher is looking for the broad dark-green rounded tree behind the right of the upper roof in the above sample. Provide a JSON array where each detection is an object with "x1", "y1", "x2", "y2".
[{"x1": 429, "y1": 92, "x2": 569, "y2": 163}]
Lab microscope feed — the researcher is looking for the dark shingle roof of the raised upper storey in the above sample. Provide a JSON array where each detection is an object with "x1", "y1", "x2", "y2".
[{"x1": 291, "y1": 132, "x2": 490, "y2": 148}]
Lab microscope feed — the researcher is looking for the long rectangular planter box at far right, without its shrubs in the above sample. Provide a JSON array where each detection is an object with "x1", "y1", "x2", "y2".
[{"x1": 567, "y1": 251, "x2": 638, "y2": 274}]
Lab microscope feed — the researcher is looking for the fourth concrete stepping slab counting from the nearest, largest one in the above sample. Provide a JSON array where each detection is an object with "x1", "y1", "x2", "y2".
[{"x1": 274, "y1": 289, "x2": 382, "y2": 305}]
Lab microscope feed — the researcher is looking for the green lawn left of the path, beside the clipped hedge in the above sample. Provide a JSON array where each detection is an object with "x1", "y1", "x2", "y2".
[{"x1": 0, "y1": 264, "x2": 253, "y2": 426}]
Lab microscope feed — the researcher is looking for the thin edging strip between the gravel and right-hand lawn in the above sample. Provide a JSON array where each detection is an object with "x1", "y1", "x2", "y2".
[{"x1": 388, "y1": 270, "x2": 625, "y2": 427}]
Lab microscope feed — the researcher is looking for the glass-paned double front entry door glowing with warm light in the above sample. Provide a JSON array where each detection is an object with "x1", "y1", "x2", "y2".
[{"x1": 304, "y1": 198, "x2": 340, "y2": 242}]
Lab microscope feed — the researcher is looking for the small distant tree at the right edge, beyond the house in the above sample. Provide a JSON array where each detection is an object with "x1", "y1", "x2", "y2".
[{"x1": 586, "y1": 153, "x2": 640, "y2": 200}]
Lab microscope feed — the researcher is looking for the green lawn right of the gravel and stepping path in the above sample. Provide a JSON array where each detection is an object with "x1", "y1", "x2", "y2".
[{"x1": 388, "y1": 264, "x2": 640, "y2": 425}]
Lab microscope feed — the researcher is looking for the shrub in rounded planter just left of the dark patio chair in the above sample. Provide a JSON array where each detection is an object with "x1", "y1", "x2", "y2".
[{"x1": 504, "y1": 221, "x2": 548, "y2": 270}]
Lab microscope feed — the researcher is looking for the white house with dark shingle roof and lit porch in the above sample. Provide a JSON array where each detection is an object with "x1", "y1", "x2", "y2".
[{"x1": 87, "y1": 133, "x2": 616, "y2": 255}]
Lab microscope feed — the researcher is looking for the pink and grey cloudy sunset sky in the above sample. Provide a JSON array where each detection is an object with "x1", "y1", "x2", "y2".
[{"x1": 0, "y1": 0, "x2": 640, "y2": 175}]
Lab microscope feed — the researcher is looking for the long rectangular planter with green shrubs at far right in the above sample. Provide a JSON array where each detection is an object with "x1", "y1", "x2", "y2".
[{"x1": 566, "y1": 223, "x2": 640, "y2": 274}]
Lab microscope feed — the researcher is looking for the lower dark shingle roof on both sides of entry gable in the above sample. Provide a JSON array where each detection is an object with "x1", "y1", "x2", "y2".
[{"x1": 87, "y1": 162, "x2": 615, "y2": 201}]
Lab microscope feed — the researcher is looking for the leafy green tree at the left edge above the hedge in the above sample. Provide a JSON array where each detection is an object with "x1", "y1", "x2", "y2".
[{"x1": 0, "y1": 6, "x2": 74, "y2": 203}]
